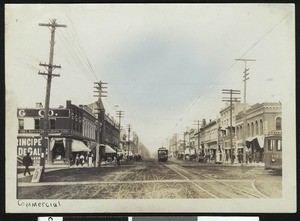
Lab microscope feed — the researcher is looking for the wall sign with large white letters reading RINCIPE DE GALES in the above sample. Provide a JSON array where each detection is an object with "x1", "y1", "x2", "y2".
[{"x1": 17, "y1": 137, "x2": 42, "y2": 164}]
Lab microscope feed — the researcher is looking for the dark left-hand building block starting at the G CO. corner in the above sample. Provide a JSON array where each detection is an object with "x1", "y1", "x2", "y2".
[{"x1": 17, "y1": 101, "x2": 119, "y2": 164}]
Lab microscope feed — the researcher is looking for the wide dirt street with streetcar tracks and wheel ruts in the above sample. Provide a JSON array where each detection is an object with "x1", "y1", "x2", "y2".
[{"x1": 17, "y1": 159, "x2": 282, "y2": 199}]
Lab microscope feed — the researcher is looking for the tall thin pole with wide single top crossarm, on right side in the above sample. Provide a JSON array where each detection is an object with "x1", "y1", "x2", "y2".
[{"x1": 235, "y1": 58, "x2": 256, "y2": 163}]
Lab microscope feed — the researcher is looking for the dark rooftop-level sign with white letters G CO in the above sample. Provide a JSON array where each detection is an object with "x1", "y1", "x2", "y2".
[{"x1": 17, "y1": 109, "x2": 70, "y2": 117}]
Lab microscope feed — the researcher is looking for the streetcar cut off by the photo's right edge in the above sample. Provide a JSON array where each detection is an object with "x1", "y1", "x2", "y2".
[{"x1": 264, "y1": 130, "x2": 282, "y2": 172}]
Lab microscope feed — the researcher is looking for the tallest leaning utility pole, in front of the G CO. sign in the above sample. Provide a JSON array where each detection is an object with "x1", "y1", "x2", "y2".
[{"x1": 38, "y1": 19, "x2": 67, "y2": 173}]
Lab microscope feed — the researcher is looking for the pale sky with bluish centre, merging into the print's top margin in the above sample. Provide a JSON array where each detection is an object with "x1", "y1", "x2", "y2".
[{"x1": 5, "y1": 4, "x2": 295, "y2": 155}]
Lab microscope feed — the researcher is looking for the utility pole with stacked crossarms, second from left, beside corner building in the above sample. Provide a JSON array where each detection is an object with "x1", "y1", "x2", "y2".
[{"x1": 94, "y1": 81, "x2": 107, "y2": 167}]
